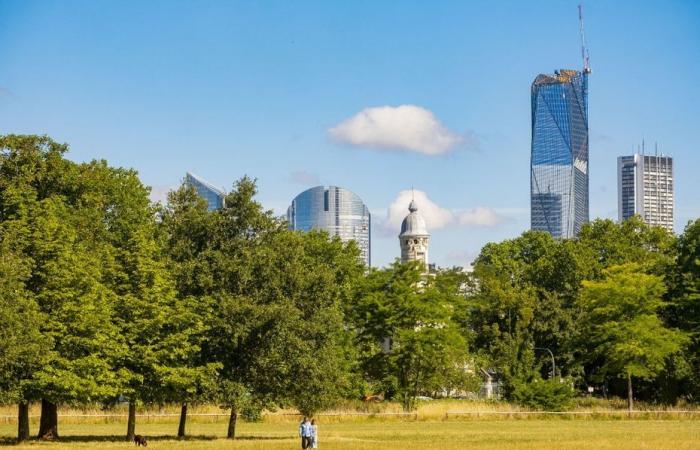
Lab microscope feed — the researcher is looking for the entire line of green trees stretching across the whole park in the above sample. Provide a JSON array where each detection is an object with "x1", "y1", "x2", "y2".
[{"x1": 0, "y1": 135, "x2": 700, "y2": 440}]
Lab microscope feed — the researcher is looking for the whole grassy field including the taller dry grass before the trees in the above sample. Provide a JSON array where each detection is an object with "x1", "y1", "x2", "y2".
[{"x1": 0, "y1": 401, "x2": 700, "y2": 450}]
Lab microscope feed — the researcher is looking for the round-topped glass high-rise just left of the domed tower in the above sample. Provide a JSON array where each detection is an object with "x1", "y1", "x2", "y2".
[{"x1": 287, "y1": 186, "x2": 371, "y2": 267}]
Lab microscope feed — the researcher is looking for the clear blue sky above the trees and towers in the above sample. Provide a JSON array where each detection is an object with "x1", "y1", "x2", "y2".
[{"x1": 0, "y1": 0, "x2": 700, "y2": 266}]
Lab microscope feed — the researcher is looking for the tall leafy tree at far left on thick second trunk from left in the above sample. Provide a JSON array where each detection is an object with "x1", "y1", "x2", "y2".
[{"x1": 0, "y1": 135, "x2": 120, "y2": 437}]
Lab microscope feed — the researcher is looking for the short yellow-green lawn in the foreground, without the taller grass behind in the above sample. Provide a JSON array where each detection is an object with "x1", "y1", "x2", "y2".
[{"x1": 0, "y1": 419, "x2": 700, "y2": 450}]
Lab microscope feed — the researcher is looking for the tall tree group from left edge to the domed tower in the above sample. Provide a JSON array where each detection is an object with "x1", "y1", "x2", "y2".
[{"x1": 0, "y1": 135, "x2": 363, "y2": 439}]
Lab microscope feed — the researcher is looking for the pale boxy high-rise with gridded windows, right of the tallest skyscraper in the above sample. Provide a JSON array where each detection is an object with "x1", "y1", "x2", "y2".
[{"x1": 617, "y1": 154, "x2": 673, "y2": 232}]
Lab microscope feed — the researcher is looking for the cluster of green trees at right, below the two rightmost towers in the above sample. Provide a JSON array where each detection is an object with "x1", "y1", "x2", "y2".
[{"x1": 468, "y1": 217, "x2": 700, "y2": 408}]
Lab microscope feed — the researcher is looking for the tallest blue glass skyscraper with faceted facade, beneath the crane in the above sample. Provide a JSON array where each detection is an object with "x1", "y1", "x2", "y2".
[{"x1": 530, "y1": 69, "x2": 590, "y2": 238}]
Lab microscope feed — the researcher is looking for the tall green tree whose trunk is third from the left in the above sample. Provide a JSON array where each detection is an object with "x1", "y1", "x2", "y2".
[{"x1": 82, "y1": 161, "x2": 220, "y2": 441}]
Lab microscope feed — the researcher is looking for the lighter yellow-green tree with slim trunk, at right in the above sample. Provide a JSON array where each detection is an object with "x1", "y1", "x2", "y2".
[{"x1": 579, "y1": 264, "x2": 687, "y2": 411}]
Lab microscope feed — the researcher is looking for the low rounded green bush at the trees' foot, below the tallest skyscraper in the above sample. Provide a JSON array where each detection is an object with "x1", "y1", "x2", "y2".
[{"x1": 512, "y1": 378, "x2": 574, "y2": 411}]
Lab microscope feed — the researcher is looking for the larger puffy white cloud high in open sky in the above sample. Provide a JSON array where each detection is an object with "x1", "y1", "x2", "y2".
[{"x1": 328, "y1": 105, "x2": 464, "y2": 155}]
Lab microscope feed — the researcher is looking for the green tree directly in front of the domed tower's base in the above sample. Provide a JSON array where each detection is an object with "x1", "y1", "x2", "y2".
[{"x1": 348, "y1": 262, "x2": 470, "y2": 411}]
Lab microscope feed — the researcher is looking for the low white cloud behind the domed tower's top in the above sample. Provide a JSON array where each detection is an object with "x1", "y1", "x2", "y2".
[{"x1": 375, "y1": 190, "x2": 506, "y2": 236}]
